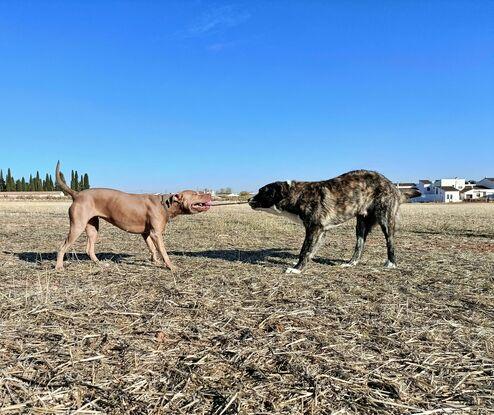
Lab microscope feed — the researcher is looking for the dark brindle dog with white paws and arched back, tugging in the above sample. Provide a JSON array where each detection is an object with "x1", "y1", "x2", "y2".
[{"x1": 249, "y1": 170, "x2": 420, "y2": 274}]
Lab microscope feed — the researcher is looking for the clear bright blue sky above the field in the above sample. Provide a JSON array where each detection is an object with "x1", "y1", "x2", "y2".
[{"x1": 0, "y1": 0, "x2": 494, "y2": 192}]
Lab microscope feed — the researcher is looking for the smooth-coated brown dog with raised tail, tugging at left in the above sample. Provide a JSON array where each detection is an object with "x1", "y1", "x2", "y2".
[{"x1": 55, "y1": 162, "x2": 211, "y2": 270}]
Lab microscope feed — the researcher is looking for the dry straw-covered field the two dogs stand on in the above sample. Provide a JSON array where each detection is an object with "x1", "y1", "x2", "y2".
[{"x1": 0, "y1": 202, "x2": 494, "y2": 415}]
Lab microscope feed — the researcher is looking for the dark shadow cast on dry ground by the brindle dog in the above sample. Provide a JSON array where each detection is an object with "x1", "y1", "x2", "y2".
[{"x1": 169, "y1": 248, "x2": 346, "y2": 266}]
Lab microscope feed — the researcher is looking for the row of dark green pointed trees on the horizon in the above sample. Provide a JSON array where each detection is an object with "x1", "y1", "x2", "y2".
[{"x1": 0, "y1": 168, "x2": 90, "y2": 192}]
